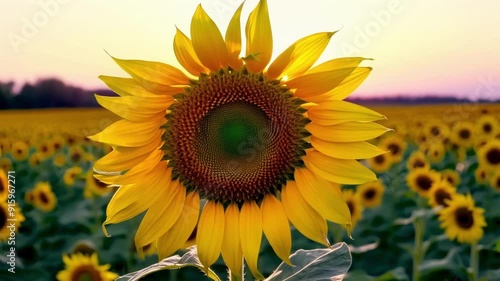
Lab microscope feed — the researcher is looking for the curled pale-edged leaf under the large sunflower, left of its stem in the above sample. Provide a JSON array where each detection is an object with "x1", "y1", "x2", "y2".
[{"x1": 117, "y1": 246, "x2": 221, "y2": 281}]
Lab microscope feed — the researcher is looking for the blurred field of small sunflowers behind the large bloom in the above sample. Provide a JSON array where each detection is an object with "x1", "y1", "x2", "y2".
[{"x1": 0, "y1": 103, "x2": 500, "y2": 281}]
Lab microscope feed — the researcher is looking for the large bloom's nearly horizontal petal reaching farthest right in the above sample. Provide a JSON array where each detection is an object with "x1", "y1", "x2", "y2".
[{"x1": 306, "y1": 122, "x2": 390, "y2": 142}]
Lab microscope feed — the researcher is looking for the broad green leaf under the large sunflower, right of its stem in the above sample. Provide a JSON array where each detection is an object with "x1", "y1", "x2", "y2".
[{"x1": 266, "y1": 242, "x2": 352, "y2": 281}]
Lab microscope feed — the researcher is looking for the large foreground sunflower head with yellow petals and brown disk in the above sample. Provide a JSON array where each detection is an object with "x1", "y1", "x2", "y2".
[{"x1": 90, "y1": 0, "x2": 387, "y2": 278}]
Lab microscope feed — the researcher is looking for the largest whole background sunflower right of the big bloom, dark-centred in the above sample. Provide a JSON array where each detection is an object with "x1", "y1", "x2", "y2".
[{"x1": 439, "y1": 194, "x2": 486, "y2": 244}]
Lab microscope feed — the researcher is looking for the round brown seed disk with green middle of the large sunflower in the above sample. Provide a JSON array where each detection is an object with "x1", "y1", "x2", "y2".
[{"x1": 163, "y1": 70, "x2": 309, "y2": 203}]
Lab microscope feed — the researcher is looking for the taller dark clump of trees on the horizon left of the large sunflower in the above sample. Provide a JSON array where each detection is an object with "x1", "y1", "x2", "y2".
[{"x1": 0, "y1": 78, "x2": 114, "y2": 109}]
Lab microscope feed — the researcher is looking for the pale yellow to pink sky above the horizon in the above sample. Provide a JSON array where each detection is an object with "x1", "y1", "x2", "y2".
[{"x1": 0, "y1": 0, "x2": 500, "y2": 99}]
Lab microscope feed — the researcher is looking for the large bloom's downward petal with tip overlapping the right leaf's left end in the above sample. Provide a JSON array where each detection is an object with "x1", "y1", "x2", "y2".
[{"x1": 261, "y1": 194, "x2": 292, "y2": 265}]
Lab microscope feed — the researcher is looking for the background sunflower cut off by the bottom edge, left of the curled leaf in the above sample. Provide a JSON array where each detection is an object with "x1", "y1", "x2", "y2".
[{"x1": 56, "y1": 253, "x2": 118, "y2": 281}]
